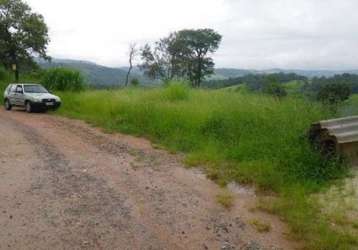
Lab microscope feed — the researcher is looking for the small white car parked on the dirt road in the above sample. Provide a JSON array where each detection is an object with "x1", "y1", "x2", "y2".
[{"x1": 4, "y1": 83, "x2": 61, "y2": 113}]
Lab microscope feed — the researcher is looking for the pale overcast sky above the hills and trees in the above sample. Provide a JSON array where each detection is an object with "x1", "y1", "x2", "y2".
[{"x1": 26, "y1": 0, "x2": 358, "y2": 69}]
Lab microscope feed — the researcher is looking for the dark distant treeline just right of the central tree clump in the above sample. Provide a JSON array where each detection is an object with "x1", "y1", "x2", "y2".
[{"x1": 204, "y1": 73, "x2": 308, "y2": 90}]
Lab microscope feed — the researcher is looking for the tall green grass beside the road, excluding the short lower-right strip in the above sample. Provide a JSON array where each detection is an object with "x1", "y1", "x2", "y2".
[{"x1": 60, "y1": 85, "x2": 337, "y2": 188}]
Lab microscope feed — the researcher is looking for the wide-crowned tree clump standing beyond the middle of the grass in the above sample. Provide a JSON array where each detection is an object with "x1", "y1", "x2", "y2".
[{"x1": 141, "y1": 29, "x2": 221, "y2": 87}]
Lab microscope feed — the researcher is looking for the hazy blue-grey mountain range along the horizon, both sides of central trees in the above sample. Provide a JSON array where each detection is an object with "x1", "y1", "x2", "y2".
[{"x1": 37, "y1": 59, "x2": 358, "y2": 86}]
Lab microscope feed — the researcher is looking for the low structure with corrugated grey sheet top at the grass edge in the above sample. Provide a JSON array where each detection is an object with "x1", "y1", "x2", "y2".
[{"x1": 309, "y1": 116, "x2": 358, "y2": 165}]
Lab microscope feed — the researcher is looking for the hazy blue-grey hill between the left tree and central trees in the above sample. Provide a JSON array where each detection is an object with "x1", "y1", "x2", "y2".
[{"x1": 38, "y1": 59, "x2": 153, "y2": 86}]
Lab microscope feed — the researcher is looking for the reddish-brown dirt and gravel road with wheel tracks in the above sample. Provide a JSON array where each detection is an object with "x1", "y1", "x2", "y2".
[{"x1": 0, "y1": 109, "x2": 293, "y2": 249}]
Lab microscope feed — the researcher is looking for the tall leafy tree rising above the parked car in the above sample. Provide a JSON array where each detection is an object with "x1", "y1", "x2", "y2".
[{"x1": 0, "y1": 0, "x2": 50, "y2": 81}]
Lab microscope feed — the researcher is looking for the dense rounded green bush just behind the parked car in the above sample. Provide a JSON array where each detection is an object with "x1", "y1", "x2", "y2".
[{"x1": 41, "y1": 68, "x2": 85, "y2": 91}]
